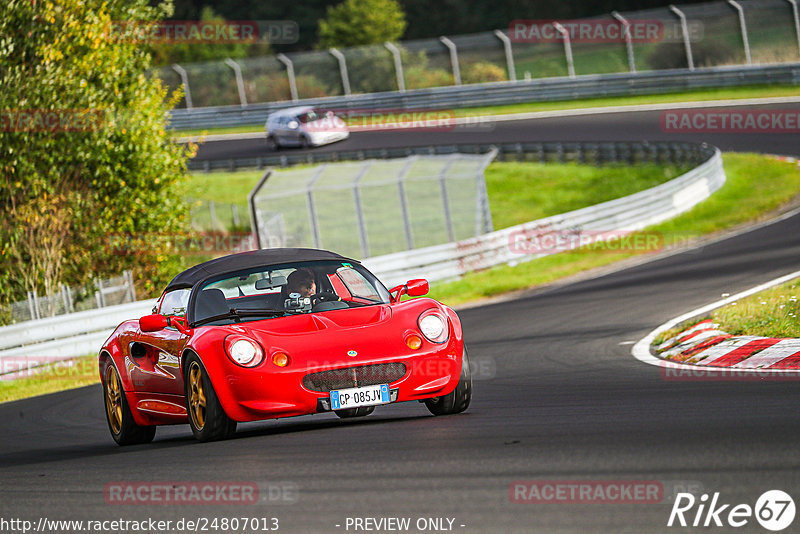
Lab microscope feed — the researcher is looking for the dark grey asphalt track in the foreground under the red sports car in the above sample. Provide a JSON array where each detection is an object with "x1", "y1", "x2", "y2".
[{"x1": 0, "y1": 102, "x2": 800, "y2": 533}]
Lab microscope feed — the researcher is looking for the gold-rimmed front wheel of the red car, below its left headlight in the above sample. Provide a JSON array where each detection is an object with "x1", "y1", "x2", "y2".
[{"x1": 183, "y1": 354, "x2": 236, "y2": 441}]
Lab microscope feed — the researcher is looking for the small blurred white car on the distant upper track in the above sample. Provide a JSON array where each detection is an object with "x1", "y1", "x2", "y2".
[{"x1": 264, "y1": 106, "x2": 350, "y2": 150}]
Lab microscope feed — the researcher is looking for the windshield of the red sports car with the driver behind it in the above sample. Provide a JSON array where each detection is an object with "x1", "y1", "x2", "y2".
[{"x1": 192, "y1": 261, "x2": 390, "y2": 325}]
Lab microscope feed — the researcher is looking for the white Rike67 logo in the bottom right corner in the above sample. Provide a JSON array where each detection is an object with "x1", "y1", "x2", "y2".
[{"x1": 667, "y1": 490, "x2": 795, "y2": 532}]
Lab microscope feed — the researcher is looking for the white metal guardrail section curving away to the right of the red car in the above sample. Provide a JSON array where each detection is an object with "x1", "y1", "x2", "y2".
[{"x1": 364, "y1": 147, "x2": 725, "y2": 286}]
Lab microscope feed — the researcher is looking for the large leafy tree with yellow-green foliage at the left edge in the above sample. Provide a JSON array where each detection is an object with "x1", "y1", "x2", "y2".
[{"x1": 0, "y1": 0, "x2": 194, "y2": 302}]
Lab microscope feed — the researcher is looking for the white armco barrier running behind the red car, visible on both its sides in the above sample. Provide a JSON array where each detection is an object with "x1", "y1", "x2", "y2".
[{"x1": 0, "y1": 143, "x2": 725, "y2": 363}]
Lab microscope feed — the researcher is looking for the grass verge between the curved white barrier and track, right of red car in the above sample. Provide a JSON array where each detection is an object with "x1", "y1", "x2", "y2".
[{"x1": 431, "y1": 154, "x2": 800, "y2": 305}]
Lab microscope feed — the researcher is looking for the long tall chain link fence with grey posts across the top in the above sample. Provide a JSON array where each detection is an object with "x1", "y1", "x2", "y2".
[{"x1": 156, "y1": 0, "x2": 800, "y2": 107}]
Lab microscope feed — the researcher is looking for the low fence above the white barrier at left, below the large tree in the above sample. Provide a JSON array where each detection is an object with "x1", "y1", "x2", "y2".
[{"x1": 0, "y1": 271, "x2": 136, "y2": 325}]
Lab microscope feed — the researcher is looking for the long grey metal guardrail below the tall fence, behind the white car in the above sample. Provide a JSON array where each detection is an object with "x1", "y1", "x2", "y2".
[{"x1": 169, "y1": 63, "x2": 800, "y2": 130}]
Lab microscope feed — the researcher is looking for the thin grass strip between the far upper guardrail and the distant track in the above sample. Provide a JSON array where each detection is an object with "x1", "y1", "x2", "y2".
[{"x1": 173, "y1": 85, "x2": 800, "y2": 137}]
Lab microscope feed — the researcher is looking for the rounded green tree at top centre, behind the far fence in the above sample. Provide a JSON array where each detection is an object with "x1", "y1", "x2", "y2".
[{"x1": 318, "y1": 0, "x2": 406, "y2": 48}]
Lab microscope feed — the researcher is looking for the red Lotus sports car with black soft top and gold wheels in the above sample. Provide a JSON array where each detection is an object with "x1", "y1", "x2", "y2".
[{"x1": 100, "y1": 249, "x2": 472, "y2": 445}]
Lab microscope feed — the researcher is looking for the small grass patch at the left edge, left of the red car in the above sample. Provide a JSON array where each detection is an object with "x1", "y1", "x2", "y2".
[{"x1": 0, "y1": 355, "x2": 100, "y2": 403}]
